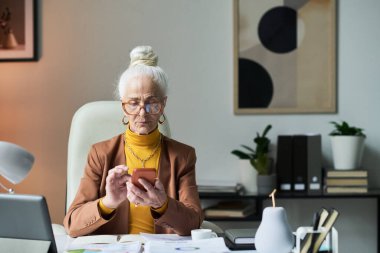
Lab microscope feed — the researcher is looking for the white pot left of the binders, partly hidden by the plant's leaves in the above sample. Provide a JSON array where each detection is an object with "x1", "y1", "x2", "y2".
[{"x1": 239, "y1": 159, "x2": 257, "y2": 194}]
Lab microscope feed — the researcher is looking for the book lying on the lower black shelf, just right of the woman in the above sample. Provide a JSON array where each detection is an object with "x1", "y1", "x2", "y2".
[{"x1": 204, "y1": 201, "x2": 256, "y2": 218}]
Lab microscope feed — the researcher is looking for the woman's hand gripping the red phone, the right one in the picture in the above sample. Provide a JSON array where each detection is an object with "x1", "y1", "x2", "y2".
[{"x1": 127, "y1": 178, "x2": 167, "y2": 208}]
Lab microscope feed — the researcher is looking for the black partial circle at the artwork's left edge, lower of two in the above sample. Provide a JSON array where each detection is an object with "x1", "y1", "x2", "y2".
[{"x1": 238, "y1": 58, "x2": 273, "y2": 108}]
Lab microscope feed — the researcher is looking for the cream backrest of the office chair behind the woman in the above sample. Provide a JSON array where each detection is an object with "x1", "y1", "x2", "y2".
[{"x1": 66, "y1": 101, "x2": 170, "y2": 212}]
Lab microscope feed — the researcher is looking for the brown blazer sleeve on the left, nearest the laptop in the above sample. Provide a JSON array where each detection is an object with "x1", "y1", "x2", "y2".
[{"x1": 63, "y1": 146, "x2": 108, "y2": 237}]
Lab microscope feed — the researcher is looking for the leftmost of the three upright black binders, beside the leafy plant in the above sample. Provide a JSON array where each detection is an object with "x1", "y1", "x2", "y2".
[{"x1": 276, "y1": 135, "x2": 293, "y2": 192}]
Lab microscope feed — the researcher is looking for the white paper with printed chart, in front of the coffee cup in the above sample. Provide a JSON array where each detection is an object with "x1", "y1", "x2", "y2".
[{"x1": 144, "y1": 237, "x2": 230, "y2": 253}]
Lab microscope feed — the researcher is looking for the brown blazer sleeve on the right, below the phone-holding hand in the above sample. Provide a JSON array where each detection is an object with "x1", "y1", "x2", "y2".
[{"x1": 152, "y1": 148, "x2": 203, "y2": 235}]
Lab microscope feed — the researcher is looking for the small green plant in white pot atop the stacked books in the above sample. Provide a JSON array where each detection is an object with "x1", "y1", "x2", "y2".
[{"x1": 329, "y1": 121, "x2": 366, "y2": 170}]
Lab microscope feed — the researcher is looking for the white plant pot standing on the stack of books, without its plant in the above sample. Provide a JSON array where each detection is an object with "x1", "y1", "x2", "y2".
[{"x1": 331, "y1": 136, "x2": 365, "y2": 170}]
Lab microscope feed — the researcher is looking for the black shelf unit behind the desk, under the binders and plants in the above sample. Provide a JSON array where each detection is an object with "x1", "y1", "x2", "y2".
[{"x1": 199, "y1": 189, "x2": 380, "y2": 253}]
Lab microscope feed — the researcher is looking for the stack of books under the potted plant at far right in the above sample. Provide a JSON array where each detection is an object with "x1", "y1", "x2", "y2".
[{"x1": 325, "y1": 170, "x2": 368, "y2": 193}]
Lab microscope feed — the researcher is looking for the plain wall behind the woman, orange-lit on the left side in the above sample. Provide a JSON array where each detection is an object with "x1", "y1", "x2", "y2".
[{"x1": 0, "y1": 0, "x2": 380, "y2": 252}]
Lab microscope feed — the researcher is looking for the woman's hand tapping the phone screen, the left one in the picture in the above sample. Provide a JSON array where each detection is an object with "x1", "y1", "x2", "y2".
[{"x1": 102, "y1": 165, "x2": 131, "y2": 208}]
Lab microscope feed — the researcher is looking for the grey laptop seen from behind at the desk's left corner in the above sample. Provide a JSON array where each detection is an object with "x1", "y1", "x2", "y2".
[{"x1": 0, "y1": 194, "x2": 57, "y2": 253}]
